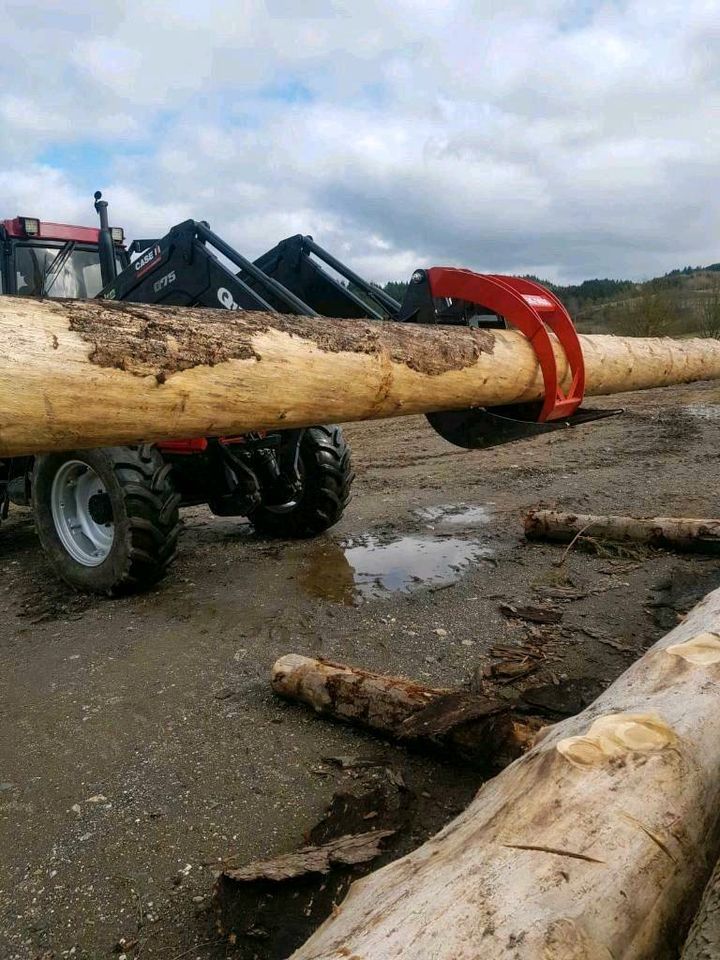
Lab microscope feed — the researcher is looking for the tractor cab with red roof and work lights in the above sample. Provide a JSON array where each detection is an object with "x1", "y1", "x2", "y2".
[{"x1": 0, "y1": 217, "x2": 130, "y2": 300}]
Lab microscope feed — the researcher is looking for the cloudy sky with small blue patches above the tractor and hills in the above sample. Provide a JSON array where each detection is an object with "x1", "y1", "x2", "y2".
[{"x1": 0, "y1": 0, "x2": 720, "y2": 282}]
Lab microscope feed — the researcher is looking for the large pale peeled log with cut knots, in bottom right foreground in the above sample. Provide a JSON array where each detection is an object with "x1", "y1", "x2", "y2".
[{"x1": 286, "y1": 590, "x2": 720, "y2": 960}]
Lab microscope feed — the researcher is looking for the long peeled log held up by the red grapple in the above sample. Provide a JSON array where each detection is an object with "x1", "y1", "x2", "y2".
[{"x1": 0, "y1": 297, "x2": 720, "y2": 456}]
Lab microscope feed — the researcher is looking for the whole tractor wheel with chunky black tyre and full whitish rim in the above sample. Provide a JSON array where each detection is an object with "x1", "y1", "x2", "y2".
[{"x1": 32, "y1": 444, "x2": 180, "y2": 593}]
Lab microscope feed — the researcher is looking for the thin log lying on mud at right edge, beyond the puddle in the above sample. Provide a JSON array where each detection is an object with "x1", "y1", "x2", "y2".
[{"x1": 525, "y1": 510, "x2": 720, "y2": 554}]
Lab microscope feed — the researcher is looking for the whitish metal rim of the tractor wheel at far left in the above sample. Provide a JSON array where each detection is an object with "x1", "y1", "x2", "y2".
[{"x1": 50, "y1": 460, "x2": 115, "y2": 567}]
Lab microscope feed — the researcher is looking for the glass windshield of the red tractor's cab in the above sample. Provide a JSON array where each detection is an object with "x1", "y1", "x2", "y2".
[{"x1": 15, "y1": 243, "x2": 113, "y2": 300}]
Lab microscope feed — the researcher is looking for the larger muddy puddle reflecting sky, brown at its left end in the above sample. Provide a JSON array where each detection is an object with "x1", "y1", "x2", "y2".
[{"x1": 298, "y1": 536, "x2": 492, "y2": 606}]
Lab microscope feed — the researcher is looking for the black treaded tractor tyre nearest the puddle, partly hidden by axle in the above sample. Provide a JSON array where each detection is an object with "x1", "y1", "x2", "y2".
[{"x1": 248, "y1": 426, "x2": 355, "y2": 538}]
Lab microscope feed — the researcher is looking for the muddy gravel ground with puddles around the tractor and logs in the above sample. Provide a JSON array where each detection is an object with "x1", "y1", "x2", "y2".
[{"x1": 0, "y1": 384, "x2": 720, "y2": 960}]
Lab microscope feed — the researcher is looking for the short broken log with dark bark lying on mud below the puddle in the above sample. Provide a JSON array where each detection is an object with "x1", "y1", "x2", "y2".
[{"x1": 272, "y1": 653, "x2": 540, "y2": 768}]
